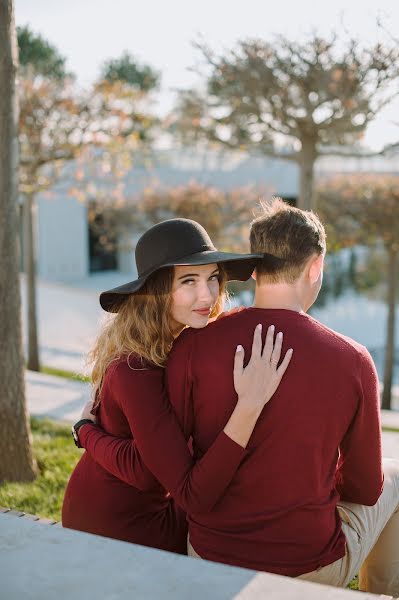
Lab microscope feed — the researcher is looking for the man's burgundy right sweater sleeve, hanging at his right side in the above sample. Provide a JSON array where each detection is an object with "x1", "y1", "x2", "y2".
[{"x1": 337, "y1": 348, "x2": 384, "y2": 506}]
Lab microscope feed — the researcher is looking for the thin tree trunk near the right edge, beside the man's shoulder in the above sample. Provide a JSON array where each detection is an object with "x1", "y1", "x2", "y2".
[{"x1": 382, "y1": 249, "x2": 399, "y2": 410}]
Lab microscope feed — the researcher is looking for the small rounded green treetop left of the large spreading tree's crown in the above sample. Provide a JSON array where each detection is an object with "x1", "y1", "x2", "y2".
[{"x1": 101, "y1": 52, "x2": 160, "y2": 93}]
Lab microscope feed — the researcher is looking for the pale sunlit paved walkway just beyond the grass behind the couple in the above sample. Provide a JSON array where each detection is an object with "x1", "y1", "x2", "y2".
[{"x1": 26, "y1": 371, "x2": 399, "y2": 458}]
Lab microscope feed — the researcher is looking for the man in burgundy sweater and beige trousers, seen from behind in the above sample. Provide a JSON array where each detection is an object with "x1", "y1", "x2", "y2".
[{"x1": 167, "y1": 200, "x2": 399, "y2": 596}]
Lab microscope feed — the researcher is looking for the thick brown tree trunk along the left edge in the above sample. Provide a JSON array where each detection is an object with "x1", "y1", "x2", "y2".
[{"x1": 0, "y1": 0, "x2": 35, "y2": 482}]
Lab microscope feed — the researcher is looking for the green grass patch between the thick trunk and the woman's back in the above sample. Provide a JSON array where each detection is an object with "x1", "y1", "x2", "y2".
[{"x1": 0, "y1": 418, "x2": 82, "y2": 521}]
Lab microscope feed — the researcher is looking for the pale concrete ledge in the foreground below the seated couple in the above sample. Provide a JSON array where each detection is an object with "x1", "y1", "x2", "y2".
[{"x1": 0, "y1": 511, "x2": 394, "y2": 600}]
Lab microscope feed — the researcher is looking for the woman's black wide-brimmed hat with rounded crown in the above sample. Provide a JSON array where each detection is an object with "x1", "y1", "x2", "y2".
[{"x1": 100, "y1": 219, "x2": 263, "y2": 312}]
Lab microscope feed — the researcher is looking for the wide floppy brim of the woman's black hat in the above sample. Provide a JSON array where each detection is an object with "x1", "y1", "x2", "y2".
[{"x1": 100, "y1": 250, "x2": 263, "y2": 312}]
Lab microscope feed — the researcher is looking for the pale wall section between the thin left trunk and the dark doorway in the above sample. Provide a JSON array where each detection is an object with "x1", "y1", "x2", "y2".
[{"x1": 36, "y1": 191, "x2": 89, "y2": 282}]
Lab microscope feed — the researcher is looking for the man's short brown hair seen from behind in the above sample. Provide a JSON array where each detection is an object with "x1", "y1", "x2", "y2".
[{"x1": 249, "y1": 198, "x2": 326, "y2": 283}]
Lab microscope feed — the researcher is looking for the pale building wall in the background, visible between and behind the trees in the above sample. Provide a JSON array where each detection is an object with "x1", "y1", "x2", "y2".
[{"x1": 32, "y1": 150, "x2": 399, "y2": 282}]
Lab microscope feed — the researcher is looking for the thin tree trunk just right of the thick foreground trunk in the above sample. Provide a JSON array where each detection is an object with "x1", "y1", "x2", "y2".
[{"x1": 24, "y1": 194, "x2": 40, "y2": 371}]
